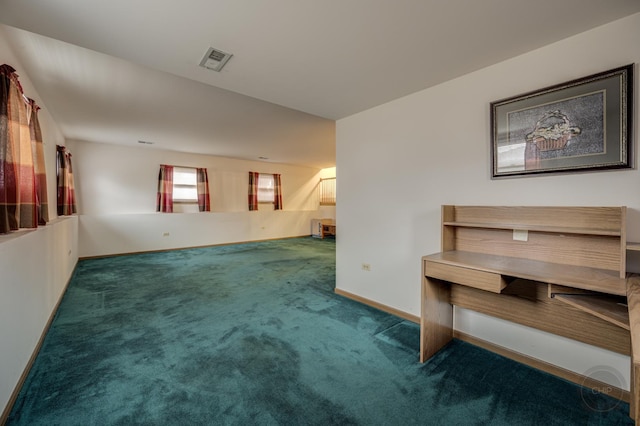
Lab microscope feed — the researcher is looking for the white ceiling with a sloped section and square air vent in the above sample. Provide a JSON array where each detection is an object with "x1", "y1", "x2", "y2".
[{"x1": 0, "y1": 0, "x2": 640, "y2": 168}]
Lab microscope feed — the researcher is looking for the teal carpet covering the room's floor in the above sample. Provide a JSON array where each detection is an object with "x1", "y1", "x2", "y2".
[{"x1": 8, "y1": 238, "x2": 632, "y2": 425}]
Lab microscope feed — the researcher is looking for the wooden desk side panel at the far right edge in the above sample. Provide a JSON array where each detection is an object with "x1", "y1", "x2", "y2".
[{"x1": 627, "y1": 275, "x2": 640, "y2": 425}]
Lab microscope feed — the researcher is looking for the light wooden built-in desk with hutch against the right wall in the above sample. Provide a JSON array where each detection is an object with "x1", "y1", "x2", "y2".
[{"x1": 420, "y1": 205, "x2": 640, "y2": 422}]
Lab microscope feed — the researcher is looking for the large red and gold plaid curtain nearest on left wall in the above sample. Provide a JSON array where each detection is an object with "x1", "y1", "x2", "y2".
[{"x1": 0, "y1": 64, "x2": 48, "y2": 233}]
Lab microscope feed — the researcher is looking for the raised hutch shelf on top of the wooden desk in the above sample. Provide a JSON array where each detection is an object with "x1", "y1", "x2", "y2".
[{"x1": 441, "y1": 205, "x2": 624, "y2": 280}]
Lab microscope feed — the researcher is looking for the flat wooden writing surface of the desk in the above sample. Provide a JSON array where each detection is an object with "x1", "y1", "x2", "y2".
[{"x1": 422, "y1": 250, "x2": 627, "y2": 296}]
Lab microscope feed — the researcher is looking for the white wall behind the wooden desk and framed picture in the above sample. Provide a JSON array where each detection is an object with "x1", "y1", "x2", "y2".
[{"x1": 336, "y1": 14, "x2": 640, "y2": 383}]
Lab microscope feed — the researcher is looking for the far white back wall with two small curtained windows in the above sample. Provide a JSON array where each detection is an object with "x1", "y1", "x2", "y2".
[{"x1": 67, "y1": 141, "x2": 335, "y2": 257}]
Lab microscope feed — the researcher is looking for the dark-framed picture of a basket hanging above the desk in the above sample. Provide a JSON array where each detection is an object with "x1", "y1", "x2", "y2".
[{"x1": 491, "y1": 64, "x2": 634, "y2": 178}]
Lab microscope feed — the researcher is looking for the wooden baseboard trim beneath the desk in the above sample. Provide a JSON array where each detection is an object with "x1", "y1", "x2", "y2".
[{"x1": 453, "y1": 330, "x2": 631, "y2": 402}]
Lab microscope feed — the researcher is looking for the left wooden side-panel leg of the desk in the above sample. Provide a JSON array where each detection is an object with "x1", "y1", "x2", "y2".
[{"x1": 420, "y1": 274, "x2": 453, "y2": 362}]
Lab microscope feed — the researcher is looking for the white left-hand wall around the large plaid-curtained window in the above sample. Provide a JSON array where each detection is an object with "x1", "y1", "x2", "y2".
[{"x1": 0, "y1": 31, "x2": 78, "y2": 418}]
